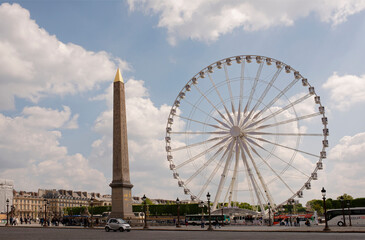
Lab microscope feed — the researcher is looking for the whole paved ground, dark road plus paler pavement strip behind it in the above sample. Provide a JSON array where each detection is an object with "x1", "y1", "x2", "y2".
[{"x1": 0, "y1": 224, "x2": 365, "y2": 240}]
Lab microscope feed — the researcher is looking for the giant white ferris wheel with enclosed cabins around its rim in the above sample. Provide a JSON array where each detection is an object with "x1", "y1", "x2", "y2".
[{"x1": 165, "y1": 55, "x2": 329, "y2": 213}]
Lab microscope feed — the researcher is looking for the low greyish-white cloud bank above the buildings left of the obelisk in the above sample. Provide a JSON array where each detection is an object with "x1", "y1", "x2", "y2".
[{"x1": 0, "y1": 106, "x2": 107, "y2": 192}]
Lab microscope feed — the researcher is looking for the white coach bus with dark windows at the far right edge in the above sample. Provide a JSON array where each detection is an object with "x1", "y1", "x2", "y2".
[{"x1": 327, "y1": 207, "x2": 365, "y2": 226}]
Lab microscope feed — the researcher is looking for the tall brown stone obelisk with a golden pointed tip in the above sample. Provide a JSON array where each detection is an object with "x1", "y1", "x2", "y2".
[{"x1": 109, "y1": 68, "x2": 134, "y2": 219}]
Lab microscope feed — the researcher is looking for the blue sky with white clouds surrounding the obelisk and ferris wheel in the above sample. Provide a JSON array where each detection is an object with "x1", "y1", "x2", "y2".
[{"x1": 0, "y1": 0, "x2": 365, "y2": 206}]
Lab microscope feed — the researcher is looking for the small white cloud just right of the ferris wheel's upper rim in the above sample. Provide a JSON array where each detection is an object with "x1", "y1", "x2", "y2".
[{"x1": 323, "y1": 72, "x2": 365, "y2": 111}]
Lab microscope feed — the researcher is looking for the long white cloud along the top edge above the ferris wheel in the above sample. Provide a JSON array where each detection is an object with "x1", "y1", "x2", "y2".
[{"x1": 128, "y1": 0, "x2": 365, "y2": 45}]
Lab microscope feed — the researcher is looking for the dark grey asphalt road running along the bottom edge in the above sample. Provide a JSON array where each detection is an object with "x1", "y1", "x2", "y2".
[{"x1": 0, "y1": 227, "x2": 365, "y2": 240}]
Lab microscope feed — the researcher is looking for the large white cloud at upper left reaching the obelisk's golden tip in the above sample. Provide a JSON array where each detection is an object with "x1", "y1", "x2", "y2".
[{"x1": 0, "y1": 3, "x2": 130, "y2": 110}]
